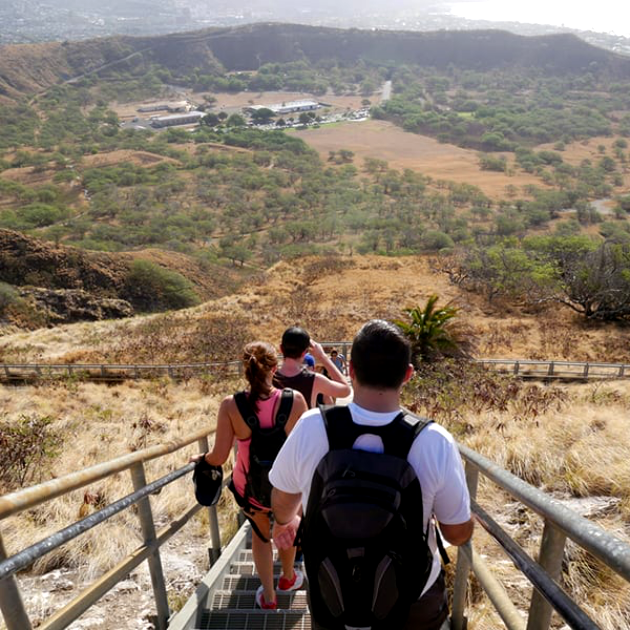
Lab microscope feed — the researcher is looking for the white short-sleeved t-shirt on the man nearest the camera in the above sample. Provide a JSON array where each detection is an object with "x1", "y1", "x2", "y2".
[{"x1": 269, "y1": 403, "x2": 470, "y2": 593}]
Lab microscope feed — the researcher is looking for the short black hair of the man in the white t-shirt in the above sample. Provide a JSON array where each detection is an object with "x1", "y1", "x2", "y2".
[{"x1": 351, "y1": 319, "x2": 411, "y2": 389}]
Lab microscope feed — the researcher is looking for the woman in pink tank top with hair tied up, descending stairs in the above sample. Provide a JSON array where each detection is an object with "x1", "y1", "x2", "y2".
[{"x1": 191, "y1": 341, "x2": 307, "y2": 609}]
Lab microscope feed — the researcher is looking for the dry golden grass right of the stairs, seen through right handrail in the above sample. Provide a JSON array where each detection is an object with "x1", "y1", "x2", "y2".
[{"x1": 424, "y1": 382, "x2": 630, "y2": 630}]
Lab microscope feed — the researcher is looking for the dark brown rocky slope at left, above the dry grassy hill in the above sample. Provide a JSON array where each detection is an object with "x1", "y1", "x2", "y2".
[{"x1": 0, "y1": 230, "x2": 242, "y2": 326}]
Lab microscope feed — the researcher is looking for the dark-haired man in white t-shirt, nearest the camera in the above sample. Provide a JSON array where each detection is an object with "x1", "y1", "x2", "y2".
[{"x1": 269, "y1": 320, "x2": 473, "y2": 630}]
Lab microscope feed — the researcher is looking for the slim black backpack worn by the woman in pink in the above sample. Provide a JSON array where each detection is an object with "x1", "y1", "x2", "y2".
[{"x1": 234, "y1": 389, "x2": 293, "y2": 507}]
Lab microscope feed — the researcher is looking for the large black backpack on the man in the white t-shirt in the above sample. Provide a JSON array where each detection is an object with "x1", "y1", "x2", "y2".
[{"x1": 301, "y1": 406, "x2": 433, "y2": 630}]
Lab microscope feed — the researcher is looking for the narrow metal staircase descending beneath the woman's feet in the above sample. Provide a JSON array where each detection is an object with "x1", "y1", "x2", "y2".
[{"x1": 168, "y1": 524, "x2": 311, "y2": 630}]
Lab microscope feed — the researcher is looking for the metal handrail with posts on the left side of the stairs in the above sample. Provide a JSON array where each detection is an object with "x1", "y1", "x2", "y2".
[{"x1": 0, "y1": 430, "x2": 221, "y2": 630}]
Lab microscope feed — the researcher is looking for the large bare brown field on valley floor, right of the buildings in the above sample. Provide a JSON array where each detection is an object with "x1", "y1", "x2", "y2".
[{"x1": 295, "y1": 120, "x2": 543, "y2": 199}]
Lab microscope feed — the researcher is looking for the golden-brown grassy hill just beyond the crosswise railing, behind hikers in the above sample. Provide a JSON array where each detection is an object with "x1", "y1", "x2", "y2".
[{"x1": 0, "y1": 255, "x2": 630, "y2": 363}]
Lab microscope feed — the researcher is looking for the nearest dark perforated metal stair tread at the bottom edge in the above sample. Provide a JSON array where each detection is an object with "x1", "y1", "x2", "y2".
[{"x1": 199, "y1": 609, "x2": 311, "y2": 630}]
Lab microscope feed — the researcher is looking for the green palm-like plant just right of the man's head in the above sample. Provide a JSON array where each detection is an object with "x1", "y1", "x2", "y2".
[{"x1": 394, "y1": 295, "x2": 469, "y2": 366}]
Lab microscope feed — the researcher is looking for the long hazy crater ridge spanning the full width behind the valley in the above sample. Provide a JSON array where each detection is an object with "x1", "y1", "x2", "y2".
[{"x1": 0, "y1": 24, "x2": 630, "y2": 101}]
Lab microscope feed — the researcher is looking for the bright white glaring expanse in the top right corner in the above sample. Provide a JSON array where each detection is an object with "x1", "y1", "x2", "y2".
[{"x1": 450, "y1": 0, "x2": 630, "y2": 37}]
